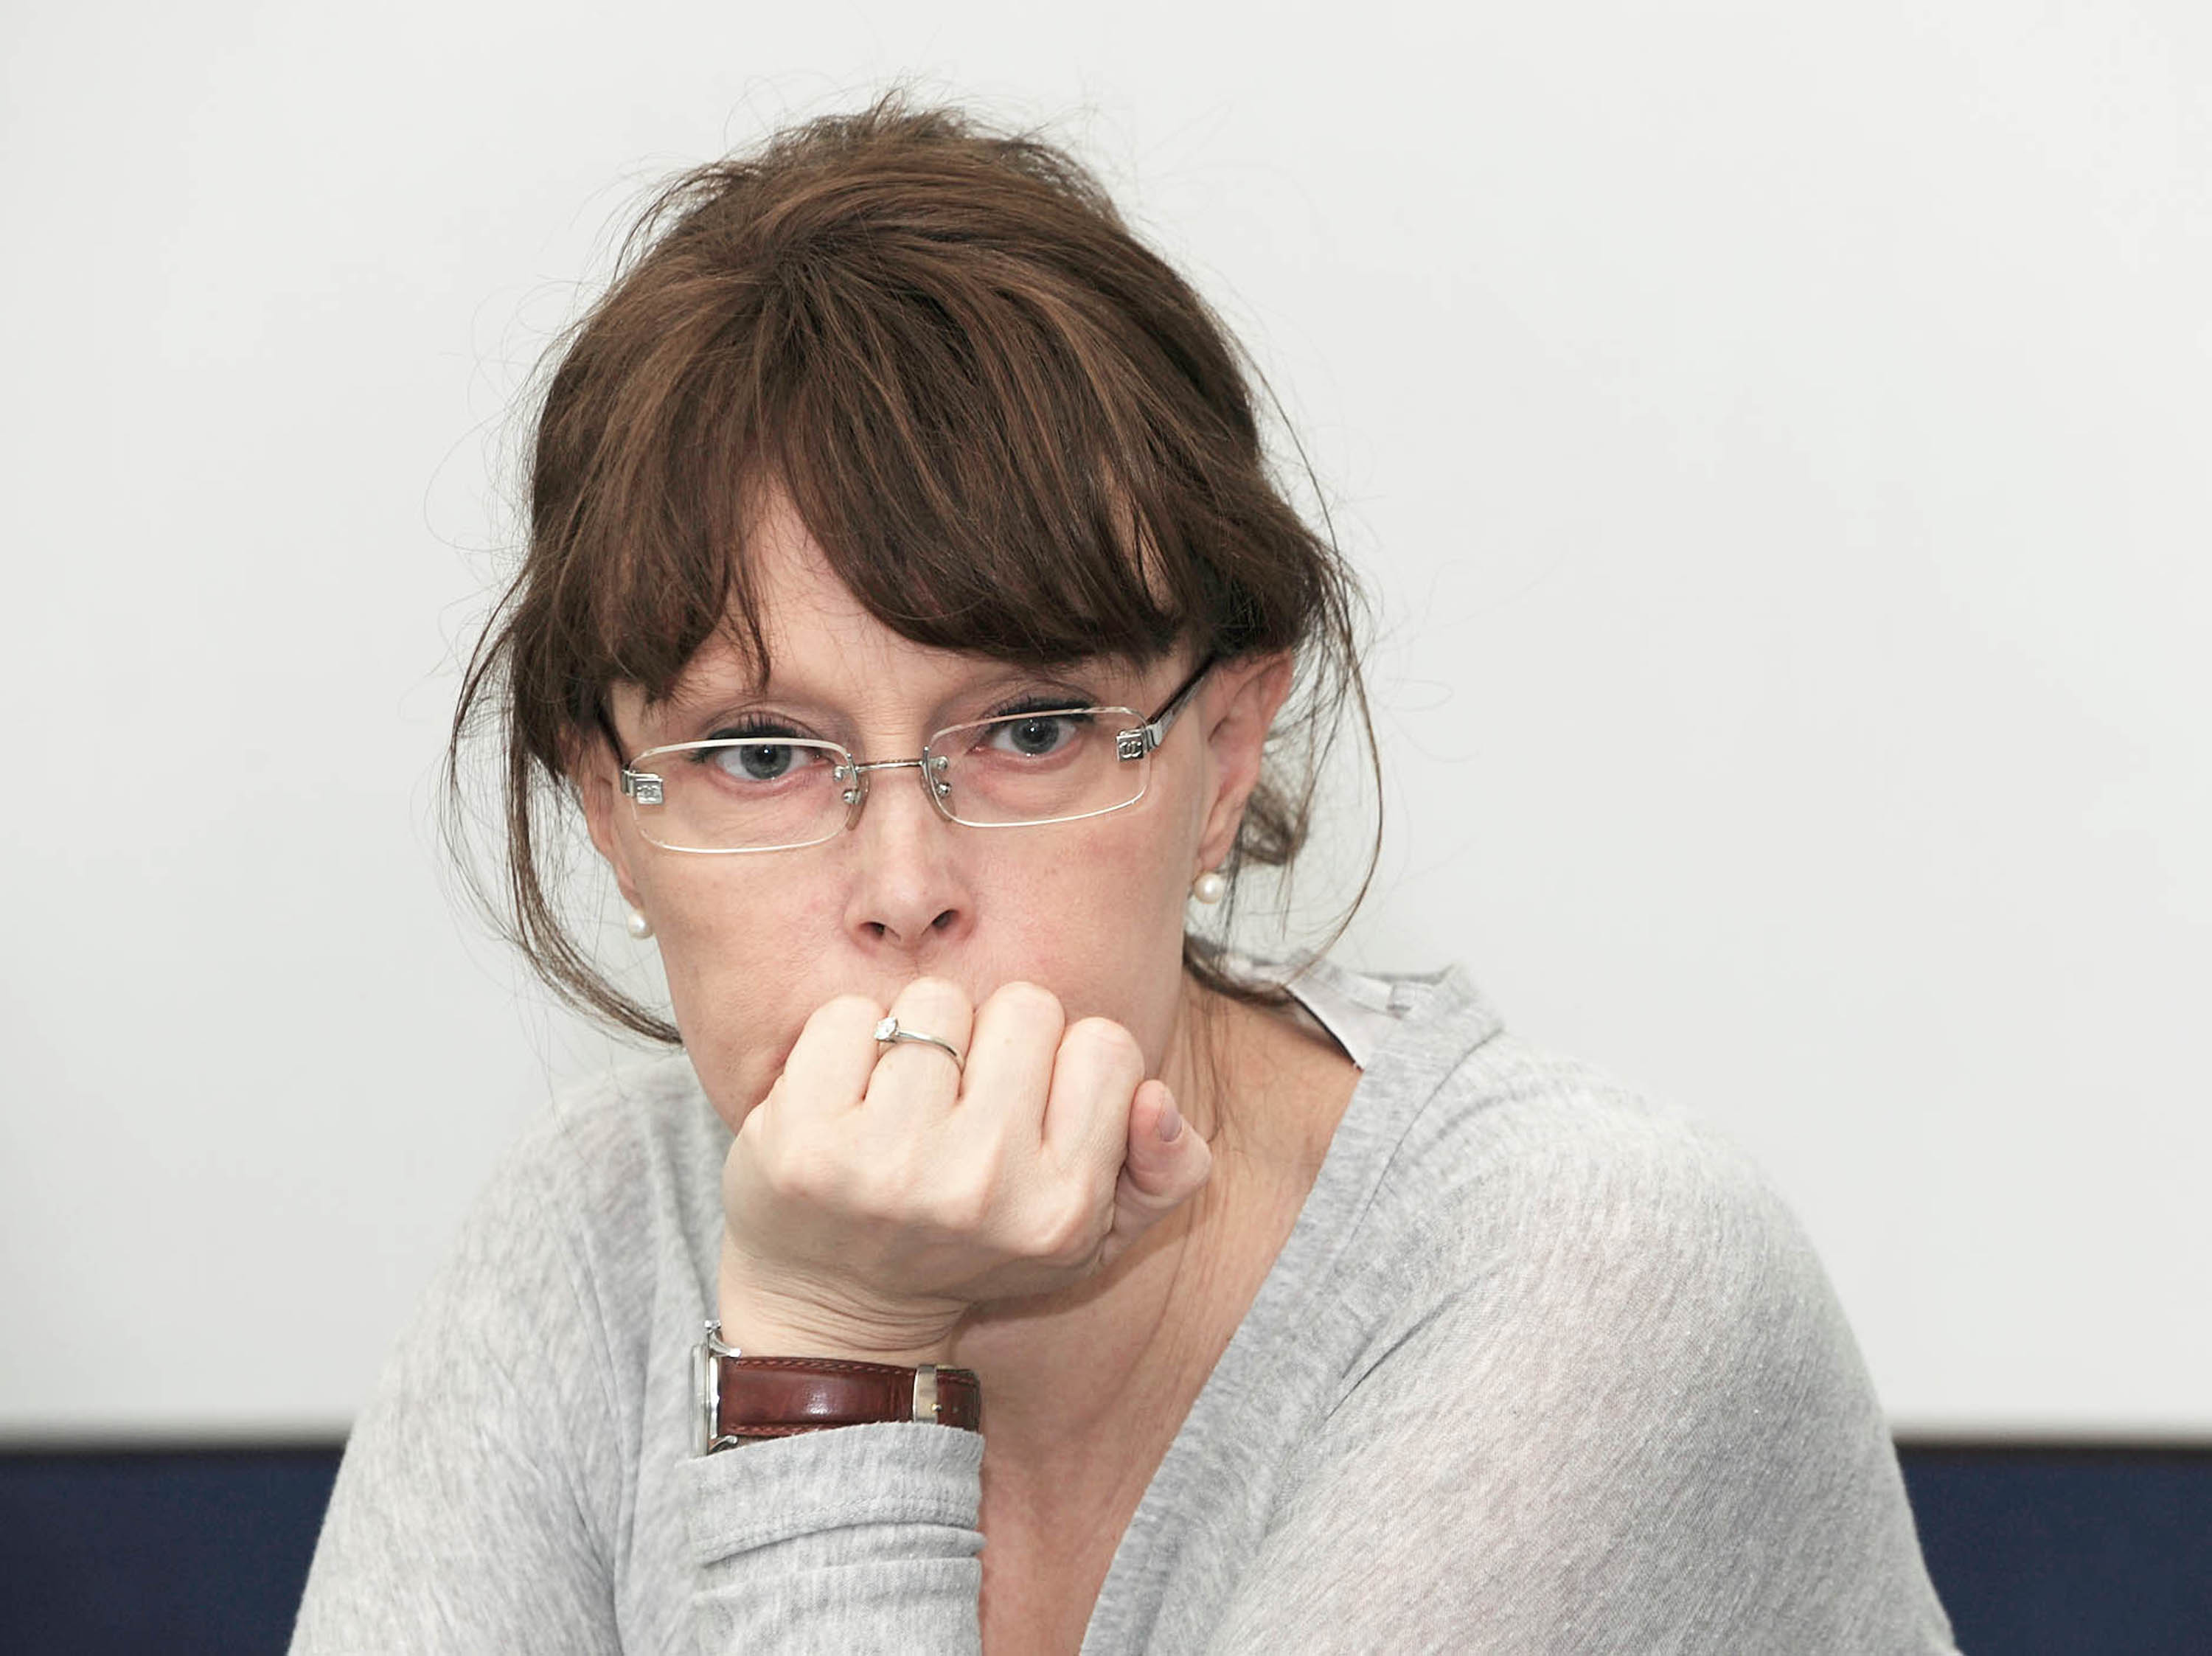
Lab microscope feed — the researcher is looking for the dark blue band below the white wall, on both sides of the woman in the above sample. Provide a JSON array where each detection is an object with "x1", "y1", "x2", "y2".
[{"x1": 0, "y1": 1444, "x2": 2212, "y2": 1656}]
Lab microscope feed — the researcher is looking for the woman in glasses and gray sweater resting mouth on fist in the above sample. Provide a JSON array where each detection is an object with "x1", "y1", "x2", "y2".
[{"x1": 294, "y1": 100, "x2": 1949, "y2": 1652}]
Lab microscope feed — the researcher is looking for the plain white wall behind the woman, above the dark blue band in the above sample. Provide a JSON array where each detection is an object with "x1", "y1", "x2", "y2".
[{"x1": 0, "y1": 0, "x2": 2212, "y2": 1439}]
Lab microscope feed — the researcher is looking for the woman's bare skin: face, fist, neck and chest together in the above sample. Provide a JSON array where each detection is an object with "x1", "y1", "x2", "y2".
[{"x1": 575, "y1": 484, "x2": 1354, "y2": 1649}]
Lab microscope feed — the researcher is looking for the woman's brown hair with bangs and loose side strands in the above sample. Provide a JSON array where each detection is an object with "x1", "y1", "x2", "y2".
[{"x1": 447, "y1": 93, "x2": 1374, "y2": 1041}]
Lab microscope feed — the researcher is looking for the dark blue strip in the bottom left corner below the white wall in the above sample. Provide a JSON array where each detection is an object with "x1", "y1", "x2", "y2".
[{"x1": 0, "y1": 1448, "x2": 338, "y2": 1656}]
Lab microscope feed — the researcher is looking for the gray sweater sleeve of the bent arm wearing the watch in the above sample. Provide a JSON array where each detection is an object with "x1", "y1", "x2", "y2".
[{"x1": 292, "y1": 1110, "x2": 982, "y2": 1656}]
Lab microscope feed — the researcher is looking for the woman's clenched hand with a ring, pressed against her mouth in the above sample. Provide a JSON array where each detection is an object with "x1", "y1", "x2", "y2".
[{"x1": 721, "y1": 977, "x2": 1212, "y2": 1362}]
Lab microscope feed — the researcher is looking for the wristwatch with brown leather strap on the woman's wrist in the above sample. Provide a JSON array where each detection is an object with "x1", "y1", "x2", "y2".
[{"x1": 692, "y1": 1322, "x2": 982, "y2": 1455}]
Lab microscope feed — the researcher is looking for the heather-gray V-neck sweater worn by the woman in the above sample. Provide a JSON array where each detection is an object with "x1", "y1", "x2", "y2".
[{"x1": 292, "y1": 961, "x2": 1953, "y2": 1656}]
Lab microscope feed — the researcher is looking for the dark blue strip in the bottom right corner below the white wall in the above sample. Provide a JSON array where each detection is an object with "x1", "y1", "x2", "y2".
[{"x1": 1898, "y1": 1444, "x2": 2212, "y2": 1656}]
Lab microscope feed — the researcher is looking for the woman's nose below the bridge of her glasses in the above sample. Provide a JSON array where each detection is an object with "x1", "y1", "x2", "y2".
[{"x1": 845, "y1": 751, "x2": 975, "y2": 961}]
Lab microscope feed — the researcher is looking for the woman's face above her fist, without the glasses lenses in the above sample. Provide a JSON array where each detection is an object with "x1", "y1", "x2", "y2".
[{"x1": 580, "y1": 500, "x2": 1290, "y2": 1127}]
